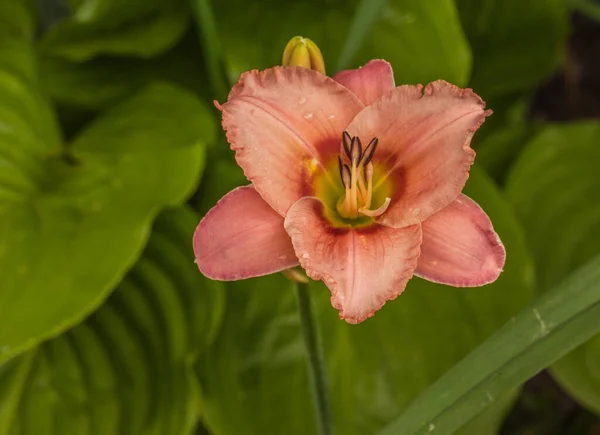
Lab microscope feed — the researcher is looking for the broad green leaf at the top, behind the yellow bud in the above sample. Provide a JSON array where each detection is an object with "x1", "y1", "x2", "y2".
[{"x1": 214, "y1": 0, "x2": 471, "y2": 85}]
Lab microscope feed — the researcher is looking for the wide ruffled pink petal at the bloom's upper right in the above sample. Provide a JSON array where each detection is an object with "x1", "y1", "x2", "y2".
[{"x1": 347, "y1": 80, "x2": 491, "y2": 228}]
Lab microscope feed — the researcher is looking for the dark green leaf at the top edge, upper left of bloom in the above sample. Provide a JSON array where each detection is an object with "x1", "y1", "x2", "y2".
[{"x1": 42, "y1": 0, "x2": 189, "y2": 61}]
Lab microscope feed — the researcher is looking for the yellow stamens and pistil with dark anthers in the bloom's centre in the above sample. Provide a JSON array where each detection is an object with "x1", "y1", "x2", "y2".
[{"x1": 337, "y1": 132, "x2": 391, "y2": 219}]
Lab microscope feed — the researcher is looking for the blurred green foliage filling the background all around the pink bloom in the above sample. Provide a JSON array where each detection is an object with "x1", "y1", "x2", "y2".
[{"x1": 0, "y1": 0, "x2": 600, "y2": 435}]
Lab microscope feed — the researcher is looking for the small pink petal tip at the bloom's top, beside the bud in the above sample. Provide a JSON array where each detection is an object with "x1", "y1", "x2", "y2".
[{"x1": 333, "y1": 60, "x2": 396, "y2": 106}]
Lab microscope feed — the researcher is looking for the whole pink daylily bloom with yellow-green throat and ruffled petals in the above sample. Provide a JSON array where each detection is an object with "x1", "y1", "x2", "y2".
[{"x1": 194, "y1": 60, "x2": 505, "y2": 323}]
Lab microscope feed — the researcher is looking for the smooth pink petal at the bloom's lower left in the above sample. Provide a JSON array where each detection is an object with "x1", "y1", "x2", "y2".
[{"x1": 194, "y1": 186, "x2": 298, "y2": 281}]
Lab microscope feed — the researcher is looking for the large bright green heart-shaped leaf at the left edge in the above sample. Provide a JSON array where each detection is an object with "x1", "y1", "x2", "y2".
[{"x1": 0, "y1": 39, "x2": 214, "y2": 361}]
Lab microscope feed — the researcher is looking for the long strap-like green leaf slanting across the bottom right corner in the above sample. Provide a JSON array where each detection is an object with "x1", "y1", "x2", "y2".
[{"x1": 378, "y1": 257, "x2": 600, "y2": 435}]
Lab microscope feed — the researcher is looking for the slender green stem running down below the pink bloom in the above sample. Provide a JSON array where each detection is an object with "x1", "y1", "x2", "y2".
[{"x1": 296, "y1": 282, "x2": 333, "y2": 435}]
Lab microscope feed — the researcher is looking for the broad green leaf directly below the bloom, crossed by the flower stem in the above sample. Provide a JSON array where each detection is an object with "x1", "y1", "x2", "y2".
[{"x1": 199, "y1": 170, "x2": 532, "y2": 435}]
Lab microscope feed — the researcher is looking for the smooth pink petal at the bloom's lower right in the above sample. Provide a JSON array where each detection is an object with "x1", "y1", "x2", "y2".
[{"x1": 415, "y1": 194, "x2": 506, "y2": 287}]
